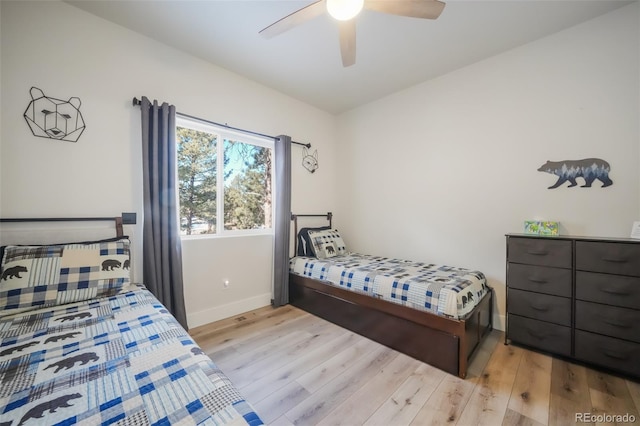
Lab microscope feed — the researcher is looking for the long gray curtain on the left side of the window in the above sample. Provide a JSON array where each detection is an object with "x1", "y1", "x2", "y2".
[{"x1": 140, "y1": 96, "x2": 187, "y2": 329}]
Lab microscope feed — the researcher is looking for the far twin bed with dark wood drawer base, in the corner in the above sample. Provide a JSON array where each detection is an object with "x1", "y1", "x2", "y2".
[{"x1": 289, "y1": 213, "x2": 493, "y2": 378}]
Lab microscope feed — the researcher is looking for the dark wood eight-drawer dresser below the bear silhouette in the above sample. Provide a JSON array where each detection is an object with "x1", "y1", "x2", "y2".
[{"x1": 505, "y1": 234, "x2": 640, "y2": 378}]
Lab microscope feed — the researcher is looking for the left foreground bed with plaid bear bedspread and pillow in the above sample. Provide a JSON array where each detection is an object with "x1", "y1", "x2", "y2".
[{"x1": 0, "y1": 218, "x2": 262, "y2": 426}]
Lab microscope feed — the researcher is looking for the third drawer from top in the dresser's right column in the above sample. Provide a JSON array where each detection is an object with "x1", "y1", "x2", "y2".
[{"x1": 576, "y1": 300, "x2": 640, "y2": 343}]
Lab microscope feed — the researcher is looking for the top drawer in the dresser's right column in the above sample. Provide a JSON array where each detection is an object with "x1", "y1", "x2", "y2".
[{"x1": 576, "y1": 241, "x2": 640, "y2": 277}]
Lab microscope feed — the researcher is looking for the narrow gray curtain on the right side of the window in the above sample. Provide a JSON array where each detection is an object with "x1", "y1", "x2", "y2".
[{"x1": 273, "y1": 135, "x2": 291, "y2": 307}]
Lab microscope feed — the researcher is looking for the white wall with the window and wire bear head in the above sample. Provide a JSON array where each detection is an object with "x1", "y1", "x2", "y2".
[{"x1": 0, "y1": 1, "x2": 336, "y2": 327}]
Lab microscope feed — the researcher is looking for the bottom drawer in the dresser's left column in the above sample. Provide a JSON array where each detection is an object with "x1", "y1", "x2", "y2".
[{"x1": 507, "y1": 314, "x2": 571, "y2": 356}]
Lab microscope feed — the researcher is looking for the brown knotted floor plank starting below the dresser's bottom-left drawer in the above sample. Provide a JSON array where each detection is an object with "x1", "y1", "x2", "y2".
[{"x1": 508, "y1": 351, "x2": 552, "y2": 425}]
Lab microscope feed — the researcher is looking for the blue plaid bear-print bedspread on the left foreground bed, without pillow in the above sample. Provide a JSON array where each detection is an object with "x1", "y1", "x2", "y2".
[{"x1": 0, "y1": 286, "x2": 262, "y2": 426}]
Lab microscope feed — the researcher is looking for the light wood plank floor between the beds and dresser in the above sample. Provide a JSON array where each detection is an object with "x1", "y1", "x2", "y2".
[{"x1": 190, "y1": 306, "x2": 640, "y2": 426}]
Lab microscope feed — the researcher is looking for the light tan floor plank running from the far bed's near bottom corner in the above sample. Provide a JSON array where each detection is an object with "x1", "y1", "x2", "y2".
[{"x1": 411, "y1": 374, "x2": 475, "y2": 426}]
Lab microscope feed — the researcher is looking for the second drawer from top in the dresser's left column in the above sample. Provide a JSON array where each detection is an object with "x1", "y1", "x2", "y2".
[{"x1": 507, "y1": 263, "x2": 571, "y2": 297}]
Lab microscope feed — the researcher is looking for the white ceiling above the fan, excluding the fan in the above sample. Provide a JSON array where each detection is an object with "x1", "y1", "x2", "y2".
[{"x1": 67, "y1": 0, "x2": 637, "y2": 114}]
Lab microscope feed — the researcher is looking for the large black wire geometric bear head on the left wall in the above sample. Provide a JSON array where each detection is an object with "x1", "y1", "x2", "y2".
[{"x1": 24, "y1": 87, "x2": 85, "y2": 142}]
